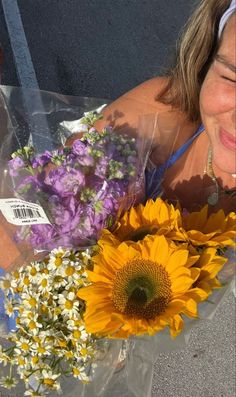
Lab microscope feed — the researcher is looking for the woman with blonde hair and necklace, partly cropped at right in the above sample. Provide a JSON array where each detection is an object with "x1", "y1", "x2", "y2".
[{"x1": 97, "y1": 0, "x2": 236, "y2": 212}]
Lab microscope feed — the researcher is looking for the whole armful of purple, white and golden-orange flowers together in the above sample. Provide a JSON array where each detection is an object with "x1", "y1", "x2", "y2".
[{"x1": 0, "y1": 86, "x2": 236, "y2": 397}]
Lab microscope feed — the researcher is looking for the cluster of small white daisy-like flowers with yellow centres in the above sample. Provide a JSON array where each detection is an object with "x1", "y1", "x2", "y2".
[{"x1": 0, "y1": 248, "x2": 96, "y2": 396}]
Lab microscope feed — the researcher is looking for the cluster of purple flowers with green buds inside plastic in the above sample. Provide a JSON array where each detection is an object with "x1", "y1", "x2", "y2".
[{"x1": 9, "y1": 114, "x2": 140, "y2": 249}]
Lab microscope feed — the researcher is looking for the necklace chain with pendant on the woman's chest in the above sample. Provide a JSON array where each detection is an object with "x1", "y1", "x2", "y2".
[{"x1": 204, "y1": 147, "x2": 236, "y2": 205}]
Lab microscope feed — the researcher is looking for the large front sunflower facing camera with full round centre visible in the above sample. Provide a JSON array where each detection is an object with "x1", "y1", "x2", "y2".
[{"x1": 77, "y1": 235, "x2": 208, "y2": 338}]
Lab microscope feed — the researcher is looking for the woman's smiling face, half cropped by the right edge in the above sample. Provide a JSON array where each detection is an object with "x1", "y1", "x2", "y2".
[{"x1": 200, "y1": 13, "x2": 236, "y2": 174}]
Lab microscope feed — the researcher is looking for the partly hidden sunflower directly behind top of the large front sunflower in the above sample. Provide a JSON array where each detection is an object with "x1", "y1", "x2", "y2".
[{"x1": 114, "y1": 198, "x2": 181, "y2": 242}]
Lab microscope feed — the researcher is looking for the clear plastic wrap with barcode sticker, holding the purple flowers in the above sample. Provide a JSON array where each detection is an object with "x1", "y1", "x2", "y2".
[{"x1": 0, "y1": 86, "x2": 155, "y2": 268}]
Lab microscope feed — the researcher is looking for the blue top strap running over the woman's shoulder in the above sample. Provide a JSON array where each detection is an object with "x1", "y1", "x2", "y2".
[{"x1": 145, "y1": 124, "x2": 204, "y2": 199}]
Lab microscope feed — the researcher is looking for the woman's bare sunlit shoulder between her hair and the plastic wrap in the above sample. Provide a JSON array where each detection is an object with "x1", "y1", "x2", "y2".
[{"x1": 96, "y1": 77, "x2": 170, "y2": 129}]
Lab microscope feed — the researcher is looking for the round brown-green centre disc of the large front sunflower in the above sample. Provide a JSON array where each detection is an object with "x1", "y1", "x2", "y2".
[{"x1": 112, "y1": 259, "x2": 171, "y2": 320}]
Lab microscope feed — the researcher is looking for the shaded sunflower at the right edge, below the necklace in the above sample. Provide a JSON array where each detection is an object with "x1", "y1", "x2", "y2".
[{"x1": 171, "y1": 205, "x2": 236, "y2": 248}]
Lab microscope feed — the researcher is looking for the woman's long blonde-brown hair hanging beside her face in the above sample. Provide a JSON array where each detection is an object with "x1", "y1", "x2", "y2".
[{"x1": 156, "y1": 0, "x2": 231, "y2": 121}]
